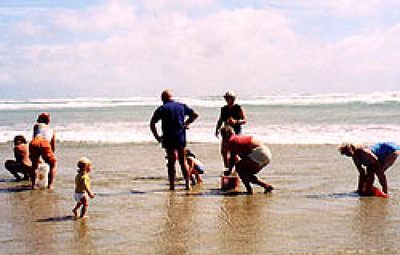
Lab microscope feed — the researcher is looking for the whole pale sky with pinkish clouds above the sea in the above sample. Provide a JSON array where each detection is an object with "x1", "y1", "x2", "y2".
[{"x1": 0, "y1": 0, "x2": 400, "y2": 99}]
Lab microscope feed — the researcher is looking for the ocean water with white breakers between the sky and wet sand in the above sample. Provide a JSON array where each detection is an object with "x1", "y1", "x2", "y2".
[{"x1": 0, "y1": 92, "x2": 400, "y2": 144}]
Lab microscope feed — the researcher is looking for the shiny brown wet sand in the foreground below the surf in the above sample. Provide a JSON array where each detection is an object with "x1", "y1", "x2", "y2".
[{"x1": 0, "y1": 143, "x2": 400, "y2": 254}]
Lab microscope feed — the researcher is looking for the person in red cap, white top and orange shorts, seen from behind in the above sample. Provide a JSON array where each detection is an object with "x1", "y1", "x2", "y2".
[{"x1": 29, "y1": 112, "x2": 57, "y2": 189}]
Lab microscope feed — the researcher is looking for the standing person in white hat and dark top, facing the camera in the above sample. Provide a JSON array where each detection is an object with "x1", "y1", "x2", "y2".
[{"x1": 215, "y1": 90, "x2": 247, "y2": 168}]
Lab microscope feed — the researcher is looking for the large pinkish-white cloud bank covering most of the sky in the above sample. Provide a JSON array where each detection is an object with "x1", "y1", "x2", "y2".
[{"x1": 0, "y1": 0, "x2": 400, "y2": 97}]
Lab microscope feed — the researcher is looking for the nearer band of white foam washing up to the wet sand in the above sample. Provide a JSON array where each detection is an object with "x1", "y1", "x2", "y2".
[{"x1": 0, "y1": 123, "x2": 400, "y2": 144}]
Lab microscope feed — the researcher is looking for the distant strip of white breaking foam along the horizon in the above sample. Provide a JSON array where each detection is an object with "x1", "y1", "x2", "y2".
[{"x1": 0, "y1": 91, "x2": 400, "y2": 110}]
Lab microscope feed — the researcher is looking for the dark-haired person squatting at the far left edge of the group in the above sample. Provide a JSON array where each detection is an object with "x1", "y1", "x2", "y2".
[{"x1": 5, "y1": 135, "x2": 32, "y2": 181}]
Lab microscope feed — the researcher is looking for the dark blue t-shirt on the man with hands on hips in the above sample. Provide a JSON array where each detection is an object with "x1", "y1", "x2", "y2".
[{"x1": 153, "y1": 101, "x2": 193, "y2": 148}]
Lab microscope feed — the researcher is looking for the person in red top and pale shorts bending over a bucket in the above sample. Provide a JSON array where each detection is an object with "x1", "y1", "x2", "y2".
[{"x1": 220, "y1": 126, "x2": 274, "y2": 194}]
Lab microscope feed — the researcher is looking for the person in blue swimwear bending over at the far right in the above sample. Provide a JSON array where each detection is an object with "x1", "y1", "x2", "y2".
[{"x1": 339, "y1": 142, "x2": 400, "y2": 196}]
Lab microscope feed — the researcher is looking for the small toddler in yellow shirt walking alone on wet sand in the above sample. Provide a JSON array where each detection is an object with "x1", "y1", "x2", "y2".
[{"x1": 72, "y1": 157, "x2": 94, "y2": 218}]
